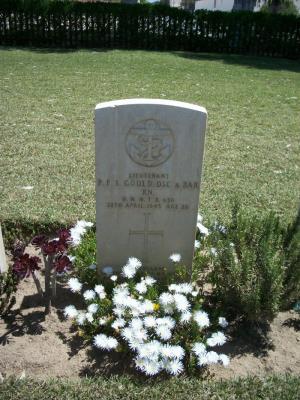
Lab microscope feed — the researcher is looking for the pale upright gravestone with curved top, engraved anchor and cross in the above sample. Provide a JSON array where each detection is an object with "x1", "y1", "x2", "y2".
[{"x1": 95, "y1": 99, "x2": 207, "y2": 276}]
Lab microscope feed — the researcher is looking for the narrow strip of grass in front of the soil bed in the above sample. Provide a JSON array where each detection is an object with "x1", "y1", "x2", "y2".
[{"x1": 0, "y1": 376, "x2": 300, "y2": 400}]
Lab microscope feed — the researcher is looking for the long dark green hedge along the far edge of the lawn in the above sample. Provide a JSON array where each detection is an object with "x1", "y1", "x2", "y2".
[{"x1": 0, "y1": 0, "x2": 300, "y2": 58}]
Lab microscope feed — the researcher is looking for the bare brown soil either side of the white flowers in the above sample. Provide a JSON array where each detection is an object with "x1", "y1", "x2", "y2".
[{"x1": 0, "y1": 279, "x2": 300, "y2": 379}]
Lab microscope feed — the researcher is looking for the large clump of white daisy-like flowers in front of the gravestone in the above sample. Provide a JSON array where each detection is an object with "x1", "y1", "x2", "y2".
[{"x1": 64, "y1": 253, "x2": 229, "y2": 376}]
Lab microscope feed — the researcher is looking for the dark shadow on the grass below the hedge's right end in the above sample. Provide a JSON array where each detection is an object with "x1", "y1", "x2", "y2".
[{"x1": 173, "y1": 51, "x2": 300, "y2": 72}]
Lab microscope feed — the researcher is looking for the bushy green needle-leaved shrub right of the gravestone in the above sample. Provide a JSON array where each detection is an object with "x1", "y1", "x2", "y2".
[{"x1": 206, "y1": 207, "x2": 285, "y2": 322}]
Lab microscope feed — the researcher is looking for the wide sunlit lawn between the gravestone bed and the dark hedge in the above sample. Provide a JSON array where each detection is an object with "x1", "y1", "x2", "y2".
[{"x1": 0, "y1": 48, "x2": 300, "y2": 231}]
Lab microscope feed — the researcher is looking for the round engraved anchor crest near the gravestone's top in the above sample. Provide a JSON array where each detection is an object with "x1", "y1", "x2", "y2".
[{"x1": 126, "y1": 119, "x2": 174, "y2": 167}]
